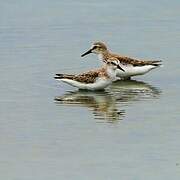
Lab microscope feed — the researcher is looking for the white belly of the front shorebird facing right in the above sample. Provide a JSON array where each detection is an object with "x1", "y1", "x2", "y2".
[{"x1": 60, "y1": 79, "x2": 112, "y2": 91}]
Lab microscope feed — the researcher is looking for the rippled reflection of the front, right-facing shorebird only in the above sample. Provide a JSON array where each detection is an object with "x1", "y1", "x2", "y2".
[{"x1": 55, "y1": 91, "x2": 124, "y2": 122}]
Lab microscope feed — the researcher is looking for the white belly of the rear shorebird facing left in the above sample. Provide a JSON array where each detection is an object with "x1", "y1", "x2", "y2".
[{"x1": 116, "y1": 64, "x2": 156, "y2": 77}]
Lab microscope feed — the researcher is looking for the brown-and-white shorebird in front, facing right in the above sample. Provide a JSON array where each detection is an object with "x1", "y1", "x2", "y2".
[{"x1": 54, "y1": 59, "x2": 124, "y2": 91}]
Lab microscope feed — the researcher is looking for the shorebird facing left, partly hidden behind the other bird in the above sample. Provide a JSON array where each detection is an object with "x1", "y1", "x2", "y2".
[{"x1": 81, "y1": 42, "x2": 161, "y2": 79}]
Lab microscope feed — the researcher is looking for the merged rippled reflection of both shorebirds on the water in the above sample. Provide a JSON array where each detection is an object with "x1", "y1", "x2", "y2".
[{"x1": 55, "y1": 80, "x2": 161, "y2": 123}]
